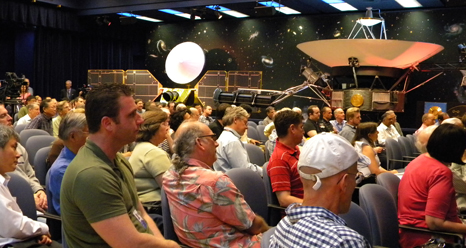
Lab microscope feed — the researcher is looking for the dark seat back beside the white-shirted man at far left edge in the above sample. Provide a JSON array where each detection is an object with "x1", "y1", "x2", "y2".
[{"x1": 8, "y1": 172, "x2": 37, "y2": 220}]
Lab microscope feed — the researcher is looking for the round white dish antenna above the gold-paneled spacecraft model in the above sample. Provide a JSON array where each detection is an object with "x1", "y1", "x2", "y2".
[{"x1": 165, "y1": 42, "x2": 205, "y2": 84}]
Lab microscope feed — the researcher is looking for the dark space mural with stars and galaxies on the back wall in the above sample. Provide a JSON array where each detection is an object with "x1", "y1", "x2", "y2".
[{"x1": 146, "y1": 9, "x2": 466, "y2": 126}]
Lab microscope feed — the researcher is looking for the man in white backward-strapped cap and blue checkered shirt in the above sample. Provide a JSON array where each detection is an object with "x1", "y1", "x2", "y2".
[{"x1": 270, "y1": 133, "x2": 371, "y2": 248}]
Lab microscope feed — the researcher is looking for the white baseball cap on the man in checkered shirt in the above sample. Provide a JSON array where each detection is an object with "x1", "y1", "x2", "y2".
[{"x1": 298, "y1": 133, "x2": 371, "y2": 190}]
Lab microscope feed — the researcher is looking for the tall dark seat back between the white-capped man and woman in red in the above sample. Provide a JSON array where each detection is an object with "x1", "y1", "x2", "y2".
[{"x1": 359, "y1": 184, "x2": 399, "y2": 247}]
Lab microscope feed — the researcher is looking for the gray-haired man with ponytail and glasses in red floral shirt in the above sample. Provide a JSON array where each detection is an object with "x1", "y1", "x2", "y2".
[{"x1": 163, "y1": 122, "x2": 269, "y2": 247}]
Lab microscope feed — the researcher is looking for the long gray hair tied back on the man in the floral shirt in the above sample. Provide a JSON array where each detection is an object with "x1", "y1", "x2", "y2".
[{"x1": 172, "y1": 122, "x2": 204, "y2": 173}]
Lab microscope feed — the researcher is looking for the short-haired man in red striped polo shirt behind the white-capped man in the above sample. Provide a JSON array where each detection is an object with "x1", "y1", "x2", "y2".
[{"x1": 267, "y1": 110, "x2": 304, "y2": 207}]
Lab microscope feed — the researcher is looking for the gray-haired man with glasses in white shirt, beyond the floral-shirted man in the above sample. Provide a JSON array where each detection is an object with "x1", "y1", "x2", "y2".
[{"x1": 214, "y1": 107, "x2": 262, "y2": 176}]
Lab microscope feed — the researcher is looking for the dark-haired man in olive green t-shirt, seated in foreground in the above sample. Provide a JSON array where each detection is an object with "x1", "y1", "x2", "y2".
[{"x1": 60, "y1": 84, "x2": 179, "y2": 247}]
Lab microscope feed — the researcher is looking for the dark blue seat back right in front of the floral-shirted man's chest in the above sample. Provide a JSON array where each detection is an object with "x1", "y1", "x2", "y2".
[{"x1": 226, "y1": 168, "x2": 268, "y2": 220}]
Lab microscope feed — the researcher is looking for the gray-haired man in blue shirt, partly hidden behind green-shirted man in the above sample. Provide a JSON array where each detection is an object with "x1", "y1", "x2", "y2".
[{"x1": 47, "y1": 112, "x2": 89, "y2": 215}]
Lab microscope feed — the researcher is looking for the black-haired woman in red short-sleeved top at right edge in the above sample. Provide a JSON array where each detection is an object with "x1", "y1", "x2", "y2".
[{"x1": 398, "y1": 124, "x2": 466, "y2": 248}]
